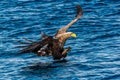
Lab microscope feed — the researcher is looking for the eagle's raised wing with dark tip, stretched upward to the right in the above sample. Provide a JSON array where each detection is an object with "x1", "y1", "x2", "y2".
[{"x1": 55, "y1": 5, "x2": 83, "y2": 36}]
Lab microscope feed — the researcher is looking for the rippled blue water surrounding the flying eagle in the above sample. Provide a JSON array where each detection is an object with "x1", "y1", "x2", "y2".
[{"x1": 0, "y1": 0, "x2": 120, "y2": 80}]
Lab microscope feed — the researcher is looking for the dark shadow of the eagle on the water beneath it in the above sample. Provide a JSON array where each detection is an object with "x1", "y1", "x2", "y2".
[{"x1": 20, "y1": 60, "x2": 67, "y2": 77}]
